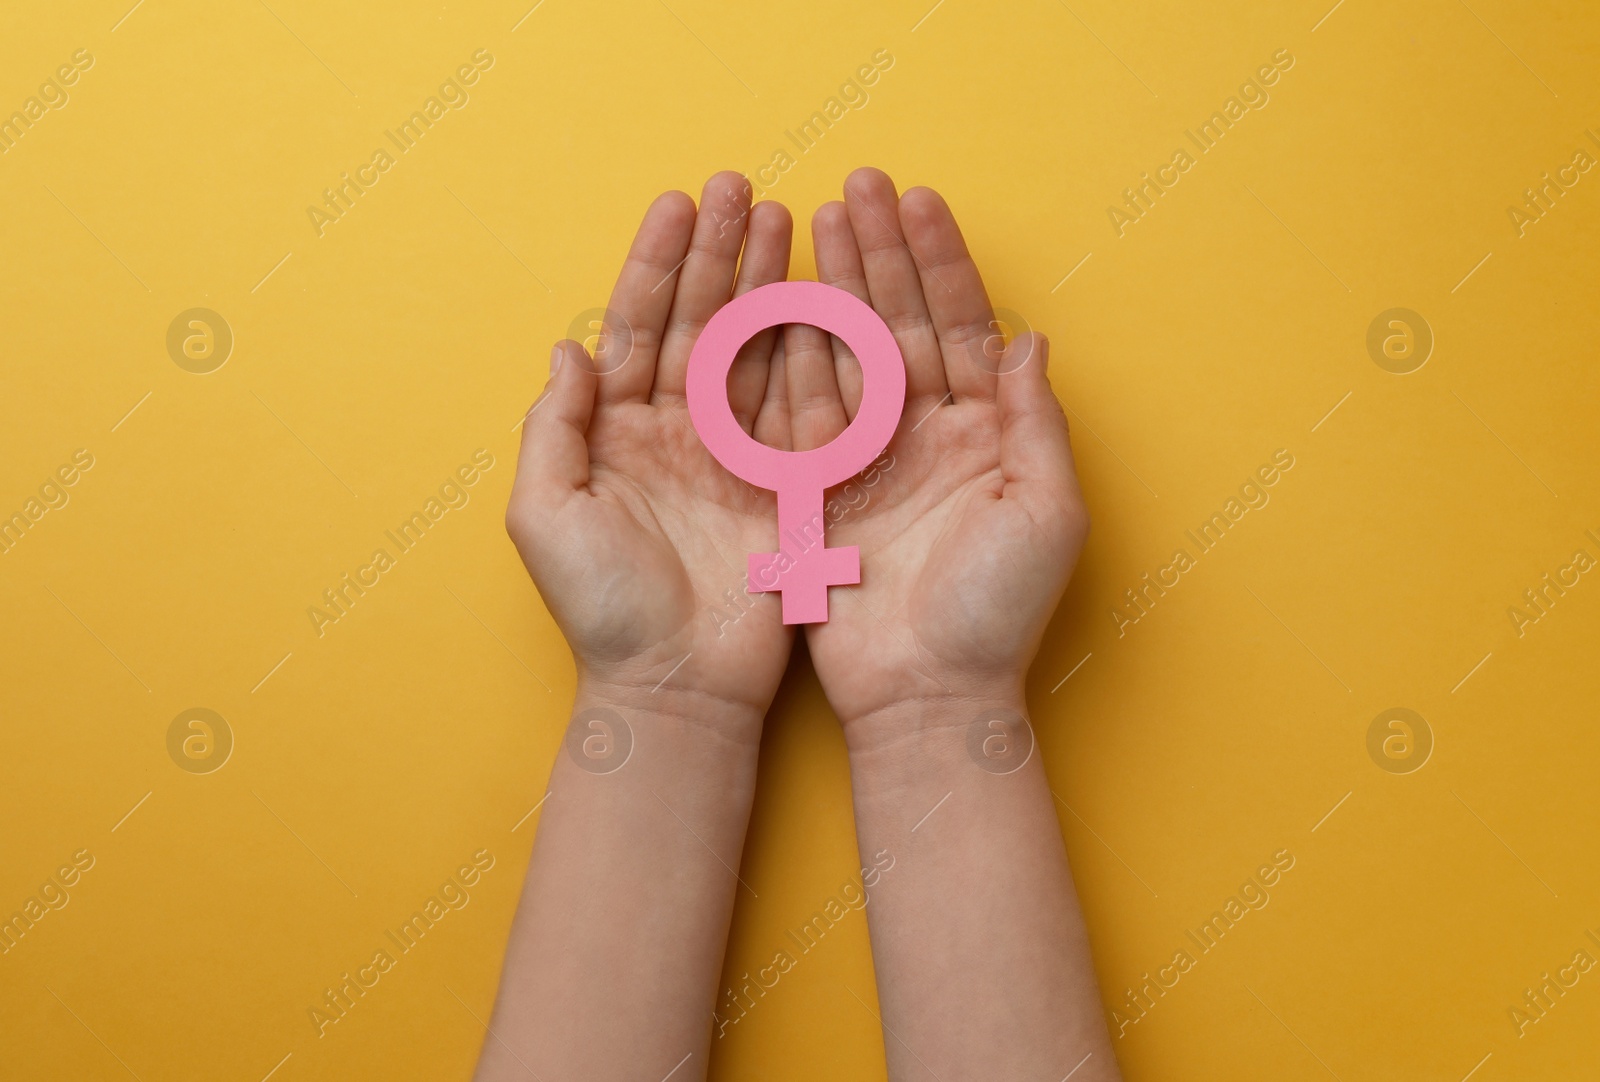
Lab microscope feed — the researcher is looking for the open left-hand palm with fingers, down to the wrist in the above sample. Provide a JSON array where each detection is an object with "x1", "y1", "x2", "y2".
[{"x1": 506, "y1": 173, "x2": 794, "y2": 727}]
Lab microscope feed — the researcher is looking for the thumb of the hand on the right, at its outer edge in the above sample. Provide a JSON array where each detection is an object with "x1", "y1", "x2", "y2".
[{"x1": 995, "y1": 331, "x2": 1086, "y2": 530}]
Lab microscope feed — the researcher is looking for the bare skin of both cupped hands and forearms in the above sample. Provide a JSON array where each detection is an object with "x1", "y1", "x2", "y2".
[{"x1": 477, "y1": 170, "x2": 1118, "y2": 1082}]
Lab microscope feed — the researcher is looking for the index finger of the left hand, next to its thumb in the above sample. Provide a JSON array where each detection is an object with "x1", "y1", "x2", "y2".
[{"x1": 586, "y1": 192, "x2": 694, "y2": 402}]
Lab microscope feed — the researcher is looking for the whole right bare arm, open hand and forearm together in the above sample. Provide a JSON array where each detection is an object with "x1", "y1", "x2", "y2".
[{"x1": 786, "y1": 170, "x2": 1118, "y2": 1082}]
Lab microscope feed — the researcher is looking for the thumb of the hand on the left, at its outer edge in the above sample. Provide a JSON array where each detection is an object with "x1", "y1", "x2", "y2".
[{"x1": 507, "y1": 341, "x2": 603, "y2": 525}]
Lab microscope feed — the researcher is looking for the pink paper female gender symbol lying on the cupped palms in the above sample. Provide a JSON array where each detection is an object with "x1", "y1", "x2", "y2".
[{"x1": 686, "y1": 282, "x2": 906, "y2": 624}]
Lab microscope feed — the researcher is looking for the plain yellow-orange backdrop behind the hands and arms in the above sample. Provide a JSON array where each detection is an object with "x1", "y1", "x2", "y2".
[{"x1": 0, "y1": 0, "x2": 1600, "y2": 1082}]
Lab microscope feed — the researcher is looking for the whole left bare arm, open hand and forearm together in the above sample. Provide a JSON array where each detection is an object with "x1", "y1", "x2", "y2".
[{"x1": 477, "y1": 173, "x2": 794, "y2": 1082}]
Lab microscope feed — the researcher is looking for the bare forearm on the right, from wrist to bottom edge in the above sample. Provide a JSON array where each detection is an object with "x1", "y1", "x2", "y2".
[{"x1": 850, "y1": 693, "x2": 1120, "y2": 1082}]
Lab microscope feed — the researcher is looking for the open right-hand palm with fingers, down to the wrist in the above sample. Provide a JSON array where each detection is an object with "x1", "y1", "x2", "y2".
[{"x1": 793, "y1": 170, "x2": 1088, "y2": 746}]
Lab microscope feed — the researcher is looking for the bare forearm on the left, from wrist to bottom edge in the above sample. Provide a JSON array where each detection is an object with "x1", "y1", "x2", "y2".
[{"x1": 477, "y1": 683, "x2": 762, "y2": 1082}]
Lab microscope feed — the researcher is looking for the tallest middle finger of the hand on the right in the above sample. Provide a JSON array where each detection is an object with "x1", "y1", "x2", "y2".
[{"x1": 845, "y1": 170, "x2": 950, "y2": 400}]
